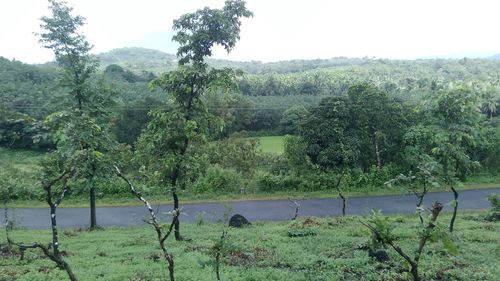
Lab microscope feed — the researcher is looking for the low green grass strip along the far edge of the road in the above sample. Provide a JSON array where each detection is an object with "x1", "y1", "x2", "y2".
[{"x1": 0, "y1": 144, "x2": 500, "y2": 208}]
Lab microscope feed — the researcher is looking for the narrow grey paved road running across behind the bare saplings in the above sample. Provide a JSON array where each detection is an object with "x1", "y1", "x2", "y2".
[{"x1": 5, "y1": 188, "x2": 500, "y2": 229}]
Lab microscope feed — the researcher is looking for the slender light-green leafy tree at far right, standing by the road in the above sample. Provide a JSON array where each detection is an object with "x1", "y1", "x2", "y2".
[{"x1": 422, "y1": 85, "x2": 484, "y2": 232}]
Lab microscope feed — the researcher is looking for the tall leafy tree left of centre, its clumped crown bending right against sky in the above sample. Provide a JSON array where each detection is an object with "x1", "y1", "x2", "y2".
[{"x1": 138, "y1": 0, "x2": 252, "y2": 240}]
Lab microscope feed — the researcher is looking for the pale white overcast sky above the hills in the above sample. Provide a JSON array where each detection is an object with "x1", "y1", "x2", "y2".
[{"x1": 0, "y1": 0, "x2": 500, "y2": 63}]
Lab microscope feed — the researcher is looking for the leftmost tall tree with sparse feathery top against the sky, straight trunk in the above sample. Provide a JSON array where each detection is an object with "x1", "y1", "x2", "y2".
[{"x1": 38, "y1": 0, "x2": 112, "y2": 229}]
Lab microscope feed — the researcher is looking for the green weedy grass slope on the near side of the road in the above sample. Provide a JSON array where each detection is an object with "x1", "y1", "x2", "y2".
[{"x1": 0, "y1": 212, "x2": 500, "y2": 281}]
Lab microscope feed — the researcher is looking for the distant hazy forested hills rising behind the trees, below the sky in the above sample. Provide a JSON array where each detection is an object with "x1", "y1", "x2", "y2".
[{"x1": 0, "y1": 48, "x2": 500, "y2": 146}]
